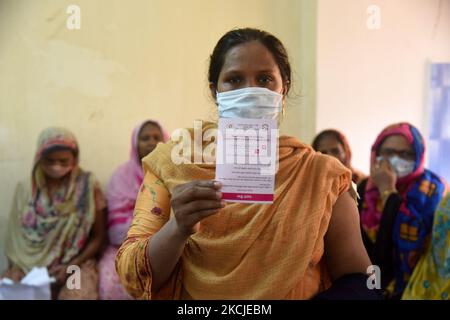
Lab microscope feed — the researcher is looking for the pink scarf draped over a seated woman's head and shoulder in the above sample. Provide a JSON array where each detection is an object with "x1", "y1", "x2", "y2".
[{"x1": 106, "y1": 120, "x2": 169, "y2": 245}]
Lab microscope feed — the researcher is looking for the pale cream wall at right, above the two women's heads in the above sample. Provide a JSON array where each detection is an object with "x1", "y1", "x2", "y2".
[{"x1": 316, "y1": 0, "x2": 450, "y2": 172}]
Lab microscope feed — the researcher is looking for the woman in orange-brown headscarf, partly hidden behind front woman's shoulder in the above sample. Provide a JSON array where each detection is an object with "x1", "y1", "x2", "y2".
[{"x1": 311, "y1": 129, "x2": 366, "y2": 184}]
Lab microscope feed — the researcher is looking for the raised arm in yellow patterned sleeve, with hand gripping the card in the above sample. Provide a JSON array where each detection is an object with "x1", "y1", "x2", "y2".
[{"x1": 116, "y1": 172, "x2": 222, "y2": 299}]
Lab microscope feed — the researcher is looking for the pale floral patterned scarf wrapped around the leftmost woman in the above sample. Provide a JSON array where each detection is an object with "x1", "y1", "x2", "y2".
[{"x1": 5, "y1": 128, "x2": 96, "y2": 272}]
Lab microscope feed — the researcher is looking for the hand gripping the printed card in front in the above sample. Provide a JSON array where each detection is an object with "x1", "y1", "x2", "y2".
[{"x1": 170, "y1": 180, "x2": 225, "y2": 237}]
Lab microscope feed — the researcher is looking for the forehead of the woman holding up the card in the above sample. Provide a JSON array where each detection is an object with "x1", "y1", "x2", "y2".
[{"x1": 222, "y1": 41, "x2": 278, "y2": 73}]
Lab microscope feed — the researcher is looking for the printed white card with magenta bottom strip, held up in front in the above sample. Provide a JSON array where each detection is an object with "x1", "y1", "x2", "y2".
[{"x1": 216, "y1": 118, "x2": 278, "y2": 203}]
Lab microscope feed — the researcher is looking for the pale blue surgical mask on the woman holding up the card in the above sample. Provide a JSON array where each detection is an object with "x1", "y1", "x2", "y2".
[{"x1": 217, "y1": 87, "x2": 283, "y2": 119}]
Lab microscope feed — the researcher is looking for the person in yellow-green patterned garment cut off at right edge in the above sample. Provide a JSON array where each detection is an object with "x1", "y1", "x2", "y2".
[{"x1": 402, "y1": 194, "x2": 450, "y2": 300}]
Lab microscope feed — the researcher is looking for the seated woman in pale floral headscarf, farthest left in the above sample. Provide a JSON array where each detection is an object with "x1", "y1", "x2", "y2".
[{"x1": 2, "y1": 128, "x2": 106, "y2": 299}]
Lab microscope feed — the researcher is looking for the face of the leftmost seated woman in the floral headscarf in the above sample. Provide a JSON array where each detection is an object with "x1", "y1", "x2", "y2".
[{"x1": 40, "y1": 150, "x2": 75, "y2": 180}]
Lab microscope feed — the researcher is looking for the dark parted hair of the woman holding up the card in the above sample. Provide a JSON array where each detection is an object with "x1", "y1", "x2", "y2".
[{"x1": 208, "y1": 28, "x2": 291, "y2": 94}]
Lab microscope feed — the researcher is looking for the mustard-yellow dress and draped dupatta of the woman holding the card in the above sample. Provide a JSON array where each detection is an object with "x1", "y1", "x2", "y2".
[{"x1": 116, "y1": 123, "x2": 351, "y2": 299}]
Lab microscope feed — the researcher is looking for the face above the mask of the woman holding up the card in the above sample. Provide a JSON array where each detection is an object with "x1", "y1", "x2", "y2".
[{"x1": 211, "y1": 41, "x2": 284, "y2": 96}]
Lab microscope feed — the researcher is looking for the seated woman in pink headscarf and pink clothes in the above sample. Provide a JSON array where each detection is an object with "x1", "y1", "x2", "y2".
[{"x1": 99, "y1": 120, "x2": 169, "y2": 300}]
